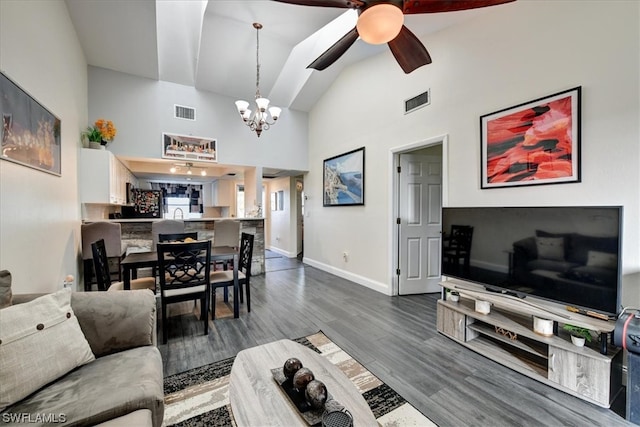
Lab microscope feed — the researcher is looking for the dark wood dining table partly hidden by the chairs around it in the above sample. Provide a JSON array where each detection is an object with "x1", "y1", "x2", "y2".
[{"x1": 120, "y1": 246, "x2": 240, "y2": 319}]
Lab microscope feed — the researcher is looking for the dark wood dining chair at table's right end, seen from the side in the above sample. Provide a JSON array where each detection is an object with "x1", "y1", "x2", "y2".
[{"x1": 211, "y1": 233, "x2": 254, "y2": 318}]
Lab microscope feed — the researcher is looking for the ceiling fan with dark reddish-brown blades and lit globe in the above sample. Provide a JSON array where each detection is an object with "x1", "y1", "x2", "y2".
[{"x1": 275, "y1": 0, "x2": 515, "y2": 74}]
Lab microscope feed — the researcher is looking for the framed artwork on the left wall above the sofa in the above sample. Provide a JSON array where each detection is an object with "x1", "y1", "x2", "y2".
[{"x1": 0, "y1": 73, "x2": 62, "y2": 176}]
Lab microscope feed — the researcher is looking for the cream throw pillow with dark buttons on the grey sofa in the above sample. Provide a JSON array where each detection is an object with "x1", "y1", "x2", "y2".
[{"x1": 0, "y1": 289, "x2": 95, "y2": 411}]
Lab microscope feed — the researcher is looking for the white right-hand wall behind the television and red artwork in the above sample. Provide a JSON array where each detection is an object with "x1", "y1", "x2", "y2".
[{"x1": 304, "y1": 1, "x2": 640, "y2": 306}]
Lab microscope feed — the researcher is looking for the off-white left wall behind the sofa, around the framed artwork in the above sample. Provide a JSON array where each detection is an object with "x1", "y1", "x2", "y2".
[{"x1": 0, "y1": 0, "x2": 87, "y2": 293}]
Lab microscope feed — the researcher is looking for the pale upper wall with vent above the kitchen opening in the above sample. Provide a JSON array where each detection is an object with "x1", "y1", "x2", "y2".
[{"x1": 89, "y1": 67, "x2": 308, "y2": 170}]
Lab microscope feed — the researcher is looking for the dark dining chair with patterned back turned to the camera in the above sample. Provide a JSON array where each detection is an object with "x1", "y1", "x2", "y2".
[{"x1": 157, "y1": 240, "x2": 211, "y2": 344}]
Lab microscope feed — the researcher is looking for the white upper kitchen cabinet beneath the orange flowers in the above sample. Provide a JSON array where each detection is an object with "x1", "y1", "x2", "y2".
[{"x1": 79, "y1": 148, "x2": 137, "y2": 205}]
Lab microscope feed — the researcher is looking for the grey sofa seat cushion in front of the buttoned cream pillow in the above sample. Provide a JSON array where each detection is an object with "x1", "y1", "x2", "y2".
[{"x1": 0, "y1": 346, "x2": 164, "y2": 426}]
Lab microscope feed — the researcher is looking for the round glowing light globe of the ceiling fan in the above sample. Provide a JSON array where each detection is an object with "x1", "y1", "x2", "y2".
[{"x1": 356, "y1": 3, "x2": 404, "y2": 44}]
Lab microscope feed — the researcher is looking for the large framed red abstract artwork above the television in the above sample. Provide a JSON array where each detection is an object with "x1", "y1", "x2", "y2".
[{"x1": 480, "y1": 87, "x2": 581, "y2": 188}]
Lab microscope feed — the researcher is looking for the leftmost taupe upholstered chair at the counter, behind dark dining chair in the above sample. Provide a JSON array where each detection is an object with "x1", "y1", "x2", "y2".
[{"x1": 80, "y1": 221, "x2": 123, "y2": 292}]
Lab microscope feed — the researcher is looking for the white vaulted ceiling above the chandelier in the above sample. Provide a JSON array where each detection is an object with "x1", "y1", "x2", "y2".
[{"x1": 66, "y1": 0, "x2": 504, "y2": 182}]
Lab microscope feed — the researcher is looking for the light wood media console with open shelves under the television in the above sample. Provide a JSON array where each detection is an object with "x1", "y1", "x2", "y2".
[{"x1": 437, "y1": 279, "x2": 622, "y2": 408}]
